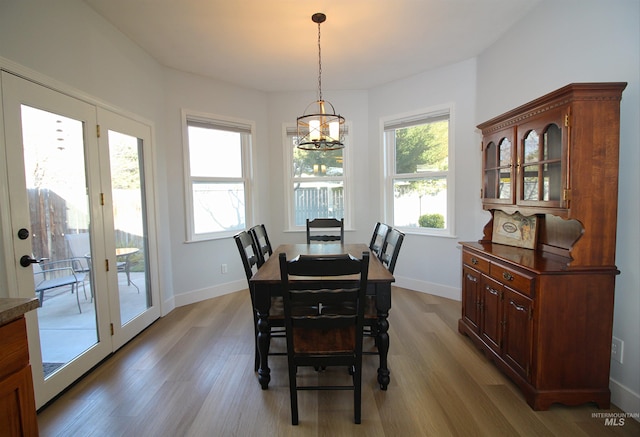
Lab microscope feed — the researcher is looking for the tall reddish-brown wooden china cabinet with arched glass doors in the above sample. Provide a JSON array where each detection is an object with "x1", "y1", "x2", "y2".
[{"x1": 458, "y1": 83, "x2": 626, "y2": 410}]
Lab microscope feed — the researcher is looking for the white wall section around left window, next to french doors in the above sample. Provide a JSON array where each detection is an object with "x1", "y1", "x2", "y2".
[{"x1": 163, "y1": 69, "x2": 270, "y2": 306}]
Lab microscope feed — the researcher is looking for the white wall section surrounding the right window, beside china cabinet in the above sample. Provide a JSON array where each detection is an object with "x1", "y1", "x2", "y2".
[{"x1": 368, "y1": 60, "x2": 488, "y2": 299}]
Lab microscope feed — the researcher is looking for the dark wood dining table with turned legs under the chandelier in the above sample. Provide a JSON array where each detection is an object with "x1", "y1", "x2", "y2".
[{"x1": 249, "y1": 243, "x2": 395, "y2": 390}]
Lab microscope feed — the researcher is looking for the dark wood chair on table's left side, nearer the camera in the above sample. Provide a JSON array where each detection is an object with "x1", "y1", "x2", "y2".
[{"x1": 233, "y1": 231, "x2": 285, "y2": 371}]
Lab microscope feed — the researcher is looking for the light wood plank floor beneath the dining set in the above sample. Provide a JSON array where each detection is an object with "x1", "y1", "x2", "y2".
[{"x1": 38, "y1": 288, "x2": 640, "y2": 437}]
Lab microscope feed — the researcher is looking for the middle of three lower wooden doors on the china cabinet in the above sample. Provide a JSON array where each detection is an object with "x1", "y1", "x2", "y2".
[{"x1": 480, "y1": 276, "x2": 503, "y2": 353}]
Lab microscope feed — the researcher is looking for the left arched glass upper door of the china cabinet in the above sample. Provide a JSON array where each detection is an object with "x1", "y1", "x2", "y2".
[{"x1": 482, "y1": 127, "x2": 516, "y2": 205}]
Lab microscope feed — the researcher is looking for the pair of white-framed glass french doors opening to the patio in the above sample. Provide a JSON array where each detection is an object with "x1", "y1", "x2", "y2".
[{"x1": 2, "y1": 72, "x2": 159, "y2": 407}]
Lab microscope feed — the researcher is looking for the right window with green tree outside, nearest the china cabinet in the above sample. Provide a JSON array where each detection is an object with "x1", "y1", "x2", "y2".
[{"x1": 384, "y1": 107, "x2": 454, "y2": 235}]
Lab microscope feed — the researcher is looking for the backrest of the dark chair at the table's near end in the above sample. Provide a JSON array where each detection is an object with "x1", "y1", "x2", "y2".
[{"x1": 279, "y1": 252, "x2": 369, "y2": 354}]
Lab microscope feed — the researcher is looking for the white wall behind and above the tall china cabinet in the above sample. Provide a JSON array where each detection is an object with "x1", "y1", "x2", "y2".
[{"x1": 476, "y1": 0, "x2": 640, "y2": 413}]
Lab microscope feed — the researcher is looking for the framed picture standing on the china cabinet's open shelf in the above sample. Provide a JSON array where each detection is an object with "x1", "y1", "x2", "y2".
[{"x1": 492, "y1": 211, "x2": 538, "y2": 249}]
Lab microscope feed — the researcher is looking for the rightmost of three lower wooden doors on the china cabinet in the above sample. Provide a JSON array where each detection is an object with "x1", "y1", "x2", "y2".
[{"x1": 502, "y1": 286, "x2": 533, "y2": 380}]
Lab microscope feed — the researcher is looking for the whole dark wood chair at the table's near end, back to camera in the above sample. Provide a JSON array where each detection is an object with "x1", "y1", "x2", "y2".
[{"x1": 279, "y1": 252, "x2": 369, "y2": 425}]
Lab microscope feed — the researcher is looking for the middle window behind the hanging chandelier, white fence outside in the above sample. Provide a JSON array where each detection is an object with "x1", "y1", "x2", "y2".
[{"x1": 284, "y1": 127, "x2": 350, "y2": 229}]
